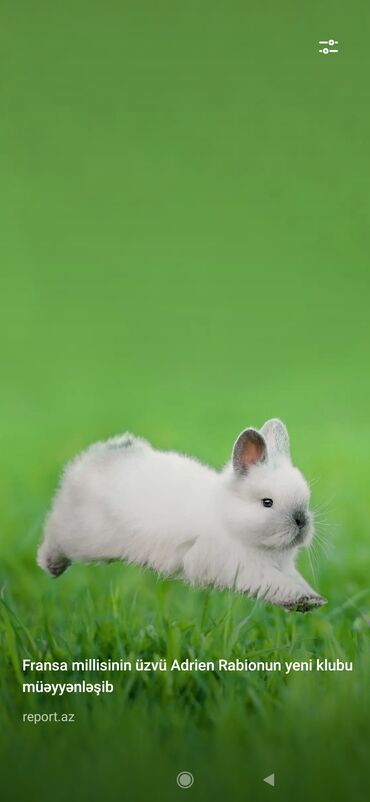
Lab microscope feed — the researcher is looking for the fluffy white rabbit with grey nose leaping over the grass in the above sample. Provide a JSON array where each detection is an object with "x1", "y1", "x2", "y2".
[{"x1": 38, "y1": 420, "x2": 325, "y2": 612}]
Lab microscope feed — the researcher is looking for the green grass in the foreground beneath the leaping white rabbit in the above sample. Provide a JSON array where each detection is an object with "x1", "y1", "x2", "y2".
[{"x1": 0, "y1": 456, "x2": 370, "y2": 800}]
